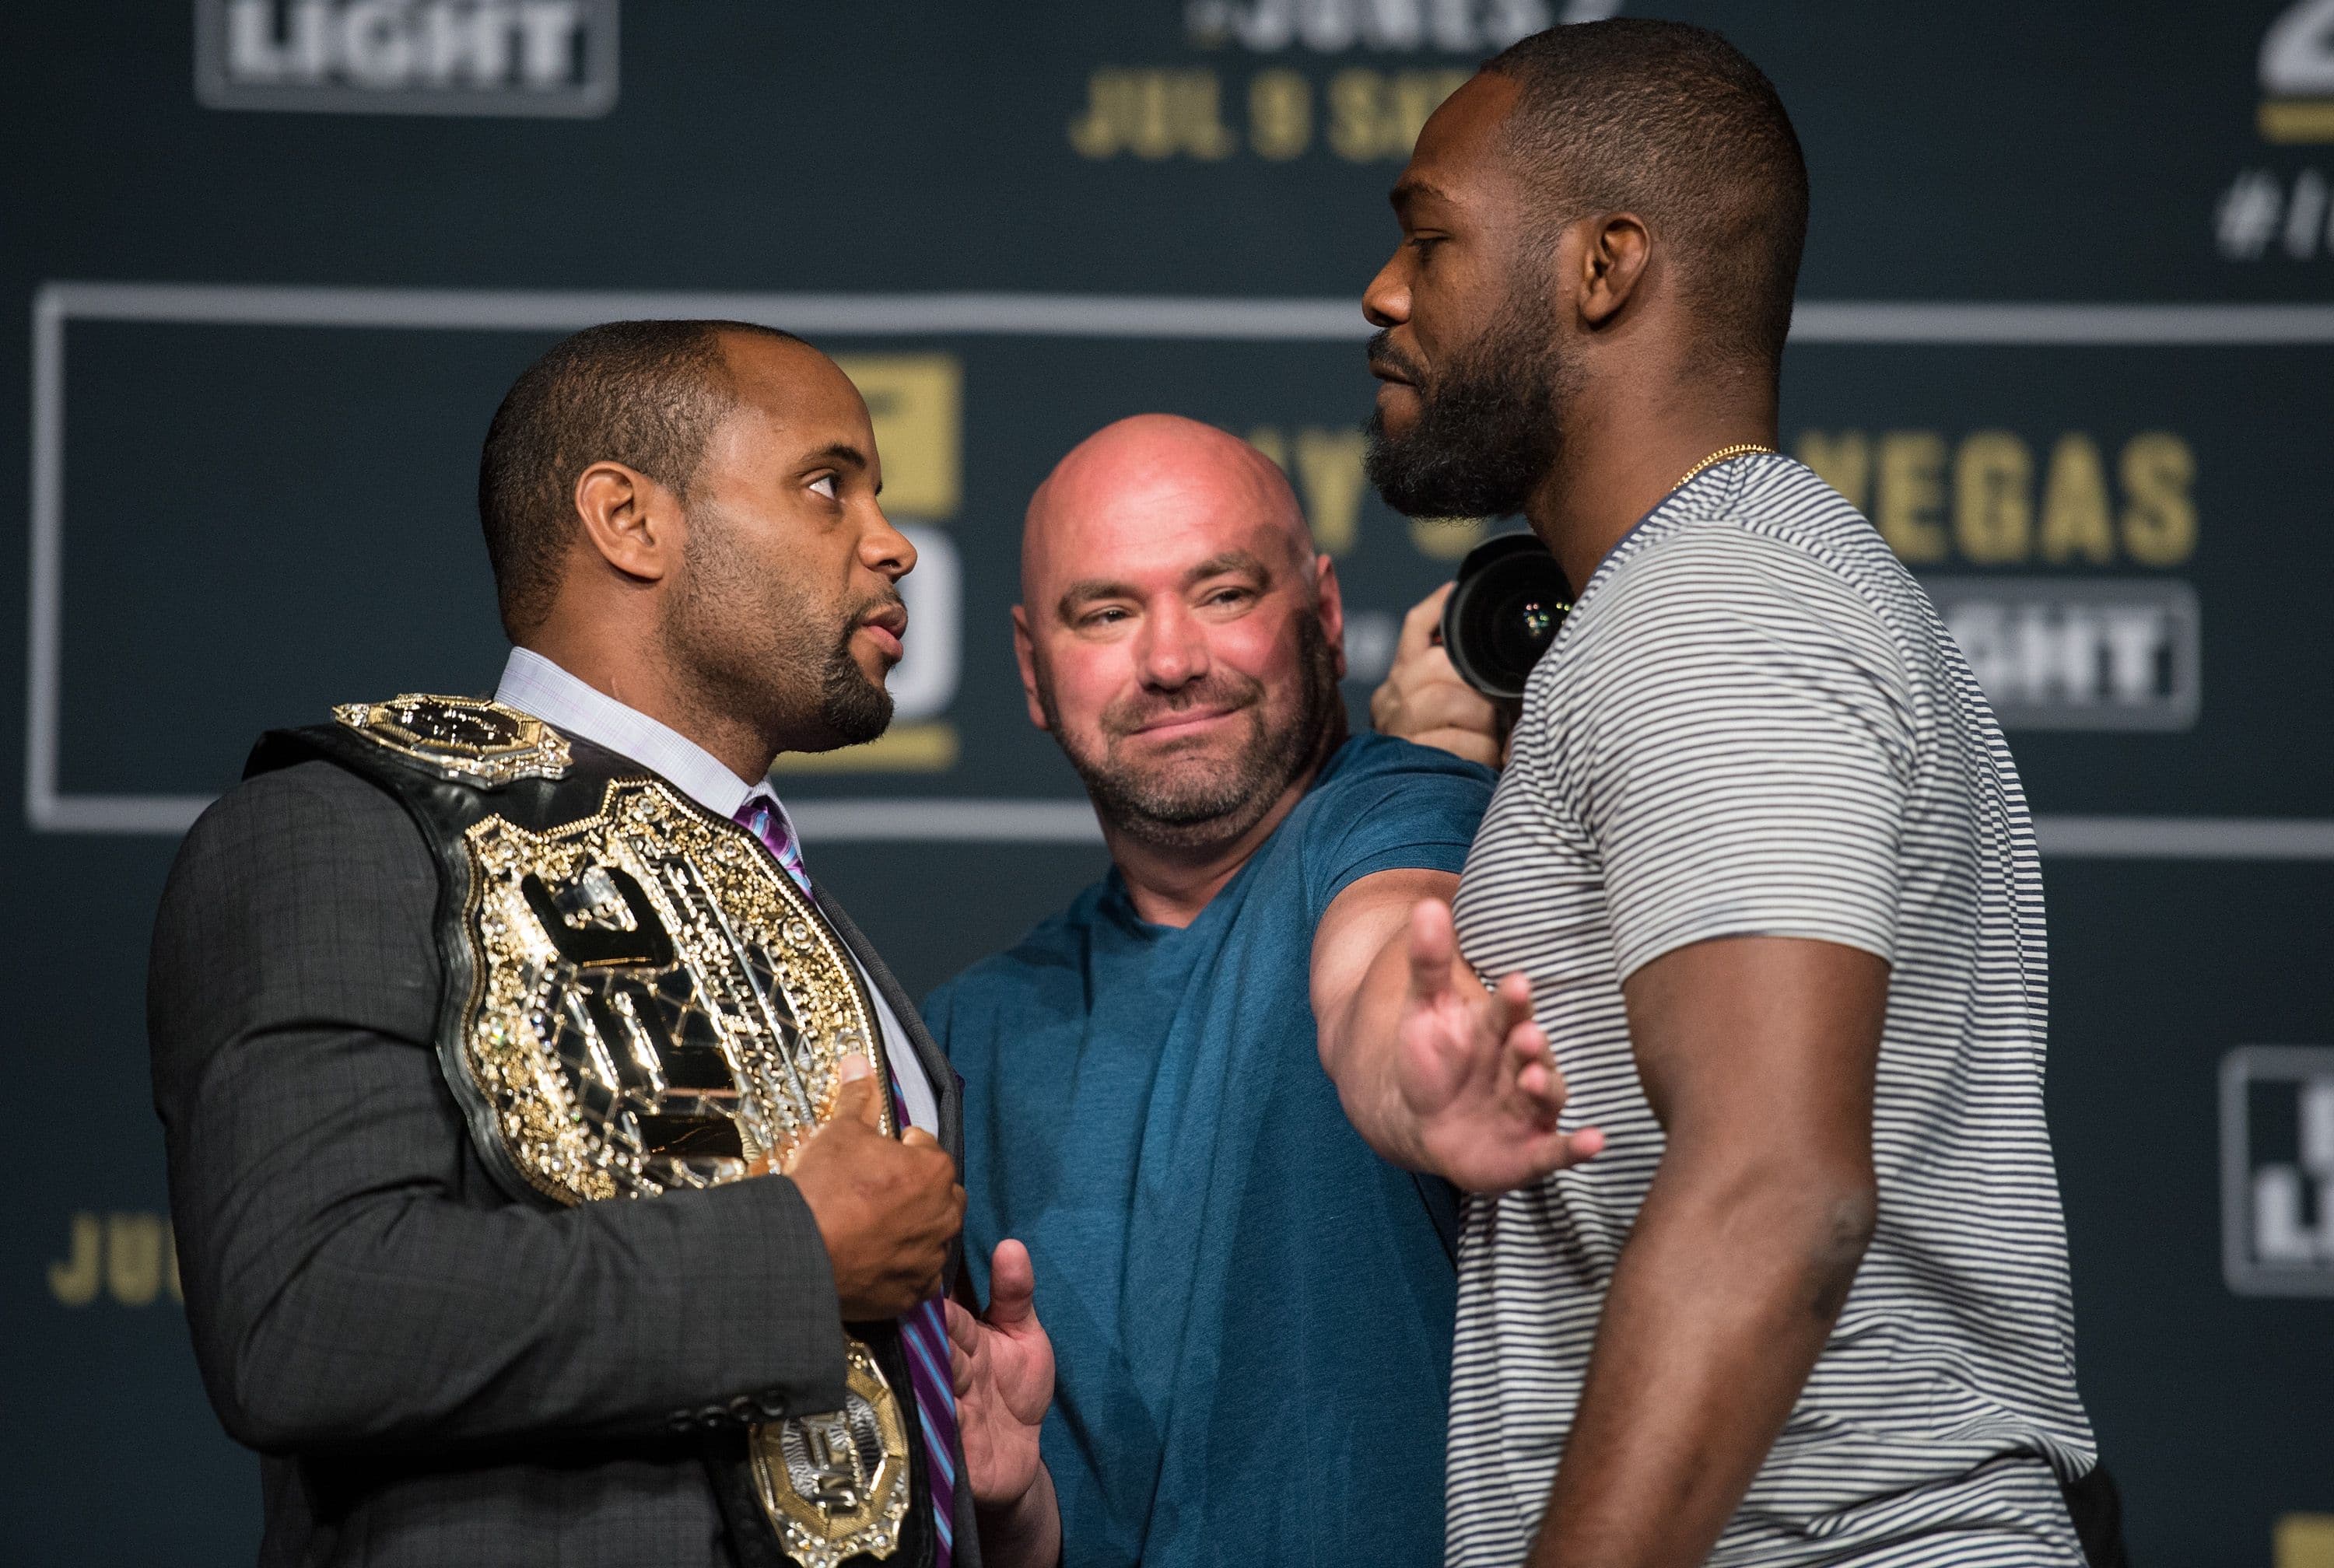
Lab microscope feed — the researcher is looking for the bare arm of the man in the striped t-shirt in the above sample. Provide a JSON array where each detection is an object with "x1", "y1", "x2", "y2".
[{"x1": 1531, "y1": 936, "x2": 1888, "y2": 1568}]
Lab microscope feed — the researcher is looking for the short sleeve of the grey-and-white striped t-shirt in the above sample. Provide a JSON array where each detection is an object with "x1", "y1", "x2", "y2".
[{"x1": 1550, "y1": 532, "x2": 1914, "y2": 980}]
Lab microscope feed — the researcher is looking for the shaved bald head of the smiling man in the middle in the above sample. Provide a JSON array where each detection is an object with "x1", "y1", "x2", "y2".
[{"x1": 1013, "y1": 413, "x2": 1344, "y2": 849}]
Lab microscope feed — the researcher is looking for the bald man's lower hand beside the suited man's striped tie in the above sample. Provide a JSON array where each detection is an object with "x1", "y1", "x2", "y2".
[{"x1": 948, "y1": 1239, "x2": 1053, "y2": 1507}]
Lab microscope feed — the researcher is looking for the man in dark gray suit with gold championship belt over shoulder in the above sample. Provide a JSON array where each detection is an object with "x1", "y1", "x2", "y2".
[{"x1": 149, "y1": 322, "x2": 1053, "y2": 1568}]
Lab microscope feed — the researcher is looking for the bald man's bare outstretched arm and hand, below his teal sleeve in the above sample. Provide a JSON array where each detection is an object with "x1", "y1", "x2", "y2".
[{"x1": 1312, "y1": 870, "x2": 1603, "y2": 1192}]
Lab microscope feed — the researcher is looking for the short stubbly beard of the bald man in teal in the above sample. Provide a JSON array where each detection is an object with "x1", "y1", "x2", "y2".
[{"x1": 1036, "y1": 614, "x2": 1347, "y2": 849}]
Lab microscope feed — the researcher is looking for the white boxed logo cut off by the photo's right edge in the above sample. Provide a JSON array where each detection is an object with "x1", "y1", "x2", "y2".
[{"x1": 2220, "y1": 1045, "x2": 2334, "y2": 1295}]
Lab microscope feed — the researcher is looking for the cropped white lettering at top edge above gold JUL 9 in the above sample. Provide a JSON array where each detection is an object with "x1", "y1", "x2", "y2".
[{"x1": 1183, "y1": 0, "x2": 1622, "y2": 54}]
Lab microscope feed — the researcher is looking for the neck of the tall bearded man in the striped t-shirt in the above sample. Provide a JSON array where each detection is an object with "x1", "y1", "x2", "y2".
[{"x1": 1524, "y1": 376, "x2": 1776, "y2": 593}]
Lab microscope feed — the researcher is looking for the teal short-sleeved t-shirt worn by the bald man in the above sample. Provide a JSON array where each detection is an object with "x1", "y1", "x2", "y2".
[{"x1": 924, "y1": 735, "x2": 1491, "y2": 1568}]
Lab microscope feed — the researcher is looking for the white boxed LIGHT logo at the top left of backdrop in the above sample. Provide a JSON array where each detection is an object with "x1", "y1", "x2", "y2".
[{"x1": 194, "y1": 0, "x2": 616, "y2": 117}]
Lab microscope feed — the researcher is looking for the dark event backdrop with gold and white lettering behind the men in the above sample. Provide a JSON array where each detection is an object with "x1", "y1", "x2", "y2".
[{"x1": 0, "y1": 0, "x2": 2334, "y2": 1568}]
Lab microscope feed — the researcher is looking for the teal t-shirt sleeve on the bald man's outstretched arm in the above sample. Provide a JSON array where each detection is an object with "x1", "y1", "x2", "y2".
[{"x1": 1305, "y1": 735, "x2": 1494, "y2": 919}]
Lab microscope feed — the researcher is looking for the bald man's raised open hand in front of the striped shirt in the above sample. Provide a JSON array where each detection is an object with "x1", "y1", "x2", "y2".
[{"x1": 1393, "y1": 898, "x2": 1603, "y2": 1192}]
